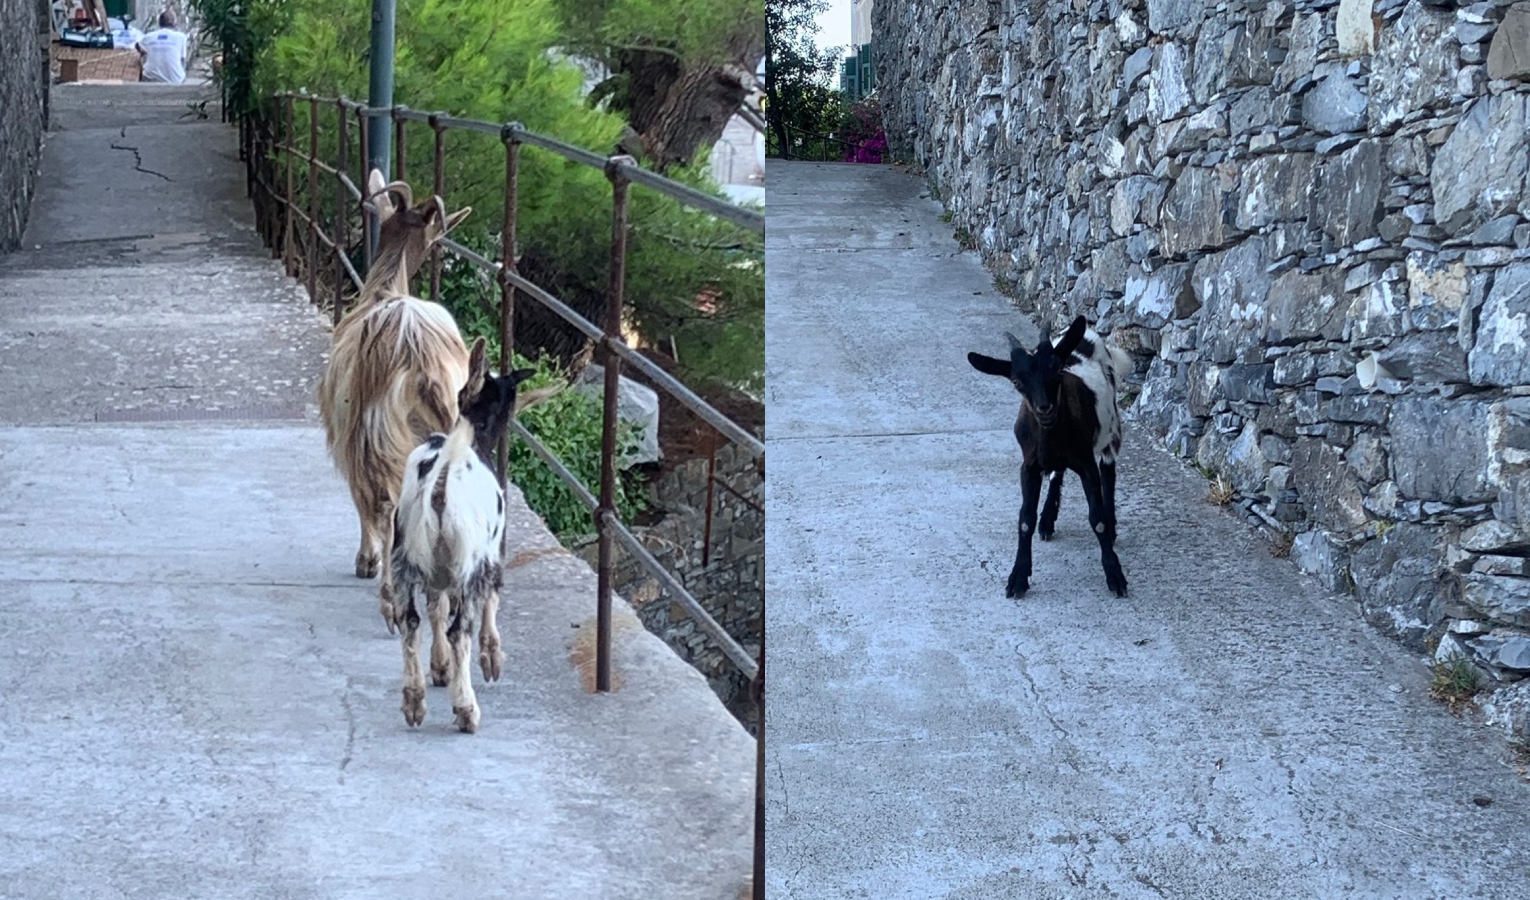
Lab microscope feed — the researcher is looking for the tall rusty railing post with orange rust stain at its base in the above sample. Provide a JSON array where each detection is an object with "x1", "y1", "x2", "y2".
[{"x1": 595, "y1": 156, "x2": 632, "y2": 692}]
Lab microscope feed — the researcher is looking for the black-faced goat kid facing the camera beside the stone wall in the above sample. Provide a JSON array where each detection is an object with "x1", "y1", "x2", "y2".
[{"x1": 967, "y1": 315, "x2": 1131, "y2": 597}]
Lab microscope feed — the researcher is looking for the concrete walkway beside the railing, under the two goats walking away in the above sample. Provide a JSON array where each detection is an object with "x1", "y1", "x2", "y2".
[{"x1": 0, "y1": 86, "x2": 754, "y2": 900}]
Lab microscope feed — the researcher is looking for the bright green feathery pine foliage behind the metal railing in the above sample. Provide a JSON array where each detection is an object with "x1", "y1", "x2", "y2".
[{"x1": 199, "y1": 0, "x2": 765, "y2": 393}]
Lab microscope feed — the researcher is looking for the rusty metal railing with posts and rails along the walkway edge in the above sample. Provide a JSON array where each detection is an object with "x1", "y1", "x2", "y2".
[{"x1": 240, "y1": 92, "x2": 765, "y2": 692}]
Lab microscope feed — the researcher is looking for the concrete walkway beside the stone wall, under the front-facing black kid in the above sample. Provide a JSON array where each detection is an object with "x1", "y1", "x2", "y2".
[{"x1": 767, "y1": 161, "x2": 1530, "y2": 900}]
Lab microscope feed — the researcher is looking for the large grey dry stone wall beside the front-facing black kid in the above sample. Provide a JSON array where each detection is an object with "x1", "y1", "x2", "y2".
[{"x1": 874, "y1": 0, "x2": 1530, "y2": 730}]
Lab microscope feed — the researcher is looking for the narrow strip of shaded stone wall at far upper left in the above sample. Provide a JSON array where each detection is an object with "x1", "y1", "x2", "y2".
[{"x1": 0, "y1": 0, "x2": 49, "y2": 253}]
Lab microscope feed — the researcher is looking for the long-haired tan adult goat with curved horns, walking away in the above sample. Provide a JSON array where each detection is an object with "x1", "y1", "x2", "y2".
[{"x1": 318, "y1": 170, "x2": 471, "y2": 632}]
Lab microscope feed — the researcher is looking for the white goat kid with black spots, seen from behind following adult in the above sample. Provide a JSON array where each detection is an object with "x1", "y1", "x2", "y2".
[{"x1": 383, "y1": 338, "x2": 534, "y2": 733}]
